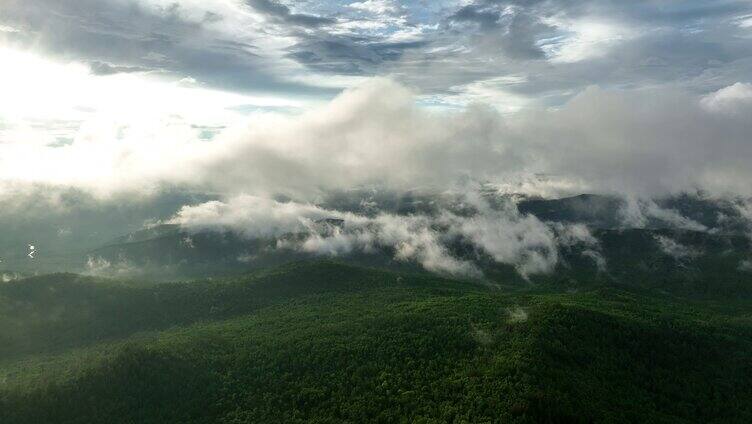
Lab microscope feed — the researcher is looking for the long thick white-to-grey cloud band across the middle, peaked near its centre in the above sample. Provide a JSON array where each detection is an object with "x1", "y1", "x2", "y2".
[{"x1": 0, "y1": 78, "x2": 752, "y2": 204}]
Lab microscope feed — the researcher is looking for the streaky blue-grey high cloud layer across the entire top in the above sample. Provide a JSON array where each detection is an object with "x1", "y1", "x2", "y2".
[{"x1": 5, "y1": 0, "x2": 752, "y2": 106}]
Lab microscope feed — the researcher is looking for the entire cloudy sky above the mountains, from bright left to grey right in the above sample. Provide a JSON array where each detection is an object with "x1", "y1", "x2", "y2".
[{"x1": 0, "y1": 0, "x2": 752, "y2": 197}]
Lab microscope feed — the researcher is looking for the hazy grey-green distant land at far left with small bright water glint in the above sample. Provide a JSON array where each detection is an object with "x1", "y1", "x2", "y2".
[{"x1": 0, "y1": 187, "x2": 216, "y2": 273}]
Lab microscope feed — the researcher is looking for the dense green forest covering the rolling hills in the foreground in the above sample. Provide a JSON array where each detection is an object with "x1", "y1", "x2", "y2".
[{"x1": 0, "y1": 262, "x2": 752, "y2": 423}]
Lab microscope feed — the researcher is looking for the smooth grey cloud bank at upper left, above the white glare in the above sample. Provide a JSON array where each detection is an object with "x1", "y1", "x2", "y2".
[{"x1": 0, "y1": 0, "x2": 331, "y2": 95}]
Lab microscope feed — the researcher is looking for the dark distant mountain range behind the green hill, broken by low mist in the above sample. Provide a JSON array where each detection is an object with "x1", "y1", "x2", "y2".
[{"x1": 0, "y1": 191, "x2": 752, "y2": 291}]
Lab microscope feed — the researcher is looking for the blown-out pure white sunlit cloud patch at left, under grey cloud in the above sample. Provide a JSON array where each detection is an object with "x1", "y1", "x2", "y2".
[{"x1": 0, "y1": 45, "x2": 301, "y2": 133}]
